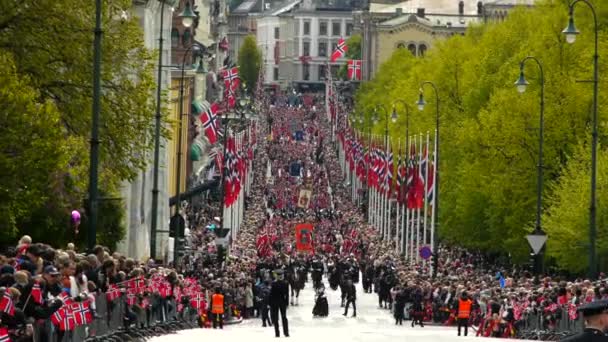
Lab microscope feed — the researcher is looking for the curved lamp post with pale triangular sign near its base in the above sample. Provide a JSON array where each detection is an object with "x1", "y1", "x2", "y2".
[{"x1": 515, "y1": 56, "x2": 546, "y2": 274}]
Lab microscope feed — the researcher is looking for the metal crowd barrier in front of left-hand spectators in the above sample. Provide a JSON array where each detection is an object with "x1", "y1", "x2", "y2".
[{"x1": 33, "y1": 293, "x2": 198, "y2": 342}]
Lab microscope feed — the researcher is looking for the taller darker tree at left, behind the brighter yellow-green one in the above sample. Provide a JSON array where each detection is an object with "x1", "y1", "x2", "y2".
[{"x1": 0, "y1": 0, "x2": 156, "y2": 243}]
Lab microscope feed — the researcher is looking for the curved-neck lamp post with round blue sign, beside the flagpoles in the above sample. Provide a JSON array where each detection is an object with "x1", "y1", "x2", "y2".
[{"x1": 416, "y1": 81, "x2": 440, "y2": 278}]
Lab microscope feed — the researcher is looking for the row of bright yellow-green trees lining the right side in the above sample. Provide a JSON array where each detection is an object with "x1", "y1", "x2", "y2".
[{"x1": 356, "y1": 0, "x2": 608, "y2": 272}]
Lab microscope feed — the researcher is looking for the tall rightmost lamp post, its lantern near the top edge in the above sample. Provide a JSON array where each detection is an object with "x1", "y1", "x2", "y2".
[{"x1": 562, "y1": 0, "x2": 599, "y2": 277}]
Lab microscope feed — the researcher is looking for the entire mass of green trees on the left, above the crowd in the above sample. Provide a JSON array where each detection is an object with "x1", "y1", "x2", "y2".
[{"x1": 0, "y1": 0, "x2": 156, "y2": 251}]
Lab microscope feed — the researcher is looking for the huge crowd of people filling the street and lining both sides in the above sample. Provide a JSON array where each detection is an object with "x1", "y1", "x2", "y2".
[{"x1": 0, "y1": 91, "x2": 608, "y2": 341}]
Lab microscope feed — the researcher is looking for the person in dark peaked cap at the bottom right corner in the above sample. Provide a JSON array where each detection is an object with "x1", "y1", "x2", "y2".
[{"x1": 562, "y1": 299, "x2": 608, "y2": 342}]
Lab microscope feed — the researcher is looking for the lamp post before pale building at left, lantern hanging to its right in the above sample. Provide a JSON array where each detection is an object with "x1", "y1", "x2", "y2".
[{"x1": 150, "y1": 0, "x2": 196, "y2": 259}]
